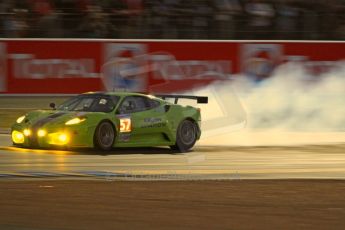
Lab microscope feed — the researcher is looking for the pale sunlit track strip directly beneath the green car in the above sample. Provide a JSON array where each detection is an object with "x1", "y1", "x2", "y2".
[{"x1": 0, "y1": 134, "x2": 345, "y2": 180}]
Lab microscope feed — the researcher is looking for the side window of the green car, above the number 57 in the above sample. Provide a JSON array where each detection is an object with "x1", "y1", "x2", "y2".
[{"x1": 119, "y1": 96, "x2": 160, "y2": 114}]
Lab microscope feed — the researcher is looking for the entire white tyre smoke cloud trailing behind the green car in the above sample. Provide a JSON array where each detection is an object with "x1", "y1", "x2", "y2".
[{"x1": 173, "y1": 63, "x2": 345, "y2": 146}]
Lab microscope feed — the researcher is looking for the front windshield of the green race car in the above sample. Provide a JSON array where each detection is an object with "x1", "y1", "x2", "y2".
[{"x1": 57, "y1": 95, "x2": 119, "y2": 113}]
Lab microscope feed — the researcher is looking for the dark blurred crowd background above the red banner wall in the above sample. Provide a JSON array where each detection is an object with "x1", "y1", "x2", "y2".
[{"x1": 0, "y1": 0, "x2": 345, "y2": 40}]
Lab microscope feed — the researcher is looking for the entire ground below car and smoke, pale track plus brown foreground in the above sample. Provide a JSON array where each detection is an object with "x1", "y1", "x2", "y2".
[{"x1": 0, "y1": 133, "x2": 345, "y2": 230}]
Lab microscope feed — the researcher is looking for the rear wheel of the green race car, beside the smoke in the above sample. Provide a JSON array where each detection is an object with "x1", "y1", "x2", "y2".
[{"x1": 170, "y1": 120, "x2": 198, "y2": 153}]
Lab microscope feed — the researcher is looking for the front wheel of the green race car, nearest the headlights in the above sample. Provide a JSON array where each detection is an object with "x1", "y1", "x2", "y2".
[{"x1": 94, "y1": 121, "x2": 115, "y2": 150}]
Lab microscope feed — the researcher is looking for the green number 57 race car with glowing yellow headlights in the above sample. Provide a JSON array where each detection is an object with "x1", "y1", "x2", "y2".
[{"x1": 11, "y1": 92, "x2": 208, "y2": 152}]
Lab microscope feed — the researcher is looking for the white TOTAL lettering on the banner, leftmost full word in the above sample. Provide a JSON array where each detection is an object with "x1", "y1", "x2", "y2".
[{"x1": 9, "y1": 54, "x2": 99, "y2": 79}]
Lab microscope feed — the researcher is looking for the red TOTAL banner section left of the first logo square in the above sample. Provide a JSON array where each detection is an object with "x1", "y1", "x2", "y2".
[{"x1": 5, "y1": 41, "x2": 101, "y2": 93}]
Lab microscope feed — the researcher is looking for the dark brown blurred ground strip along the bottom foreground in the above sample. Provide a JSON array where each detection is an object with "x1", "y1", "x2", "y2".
[{"x1": 0, "y1": 180, "x2": 345, "y2": 230}]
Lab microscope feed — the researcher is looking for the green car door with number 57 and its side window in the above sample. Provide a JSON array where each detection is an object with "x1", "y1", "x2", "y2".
[{"x1": 116, "y1": 96, "x2": 167, "y2": 146}]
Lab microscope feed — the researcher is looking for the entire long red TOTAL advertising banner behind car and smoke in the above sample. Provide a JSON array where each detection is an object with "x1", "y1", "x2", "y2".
[{"x1": 0, "y1": 40, "x2": 345, "y2": 94}]
